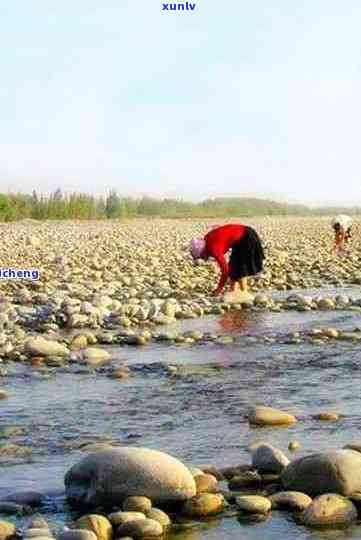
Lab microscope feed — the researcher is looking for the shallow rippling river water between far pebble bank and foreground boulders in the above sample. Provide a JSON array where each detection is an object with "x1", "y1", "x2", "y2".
[{"x1": 0, "y1": 294, "x2": 361, "y2": 540}]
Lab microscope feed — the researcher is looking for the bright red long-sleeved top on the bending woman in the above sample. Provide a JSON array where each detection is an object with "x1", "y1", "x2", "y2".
[{"x1": 204, "y1": 224, "x2": 246, "y2": 290}]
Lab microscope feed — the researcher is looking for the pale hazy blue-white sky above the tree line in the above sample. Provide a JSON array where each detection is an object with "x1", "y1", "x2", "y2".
[{"x1": 0, "y1": 0, "x2": 361, "y2": 204}]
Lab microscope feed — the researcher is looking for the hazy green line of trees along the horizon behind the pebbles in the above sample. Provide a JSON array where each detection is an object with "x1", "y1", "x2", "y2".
[{"x1": 0, "y1": 189, "x2": 361, "y2": 221}]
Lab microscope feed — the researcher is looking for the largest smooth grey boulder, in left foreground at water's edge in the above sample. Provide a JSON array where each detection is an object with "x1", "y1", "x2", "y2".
[{"x1": 64, "y1": 447, "x2": 196, "y2": 506}]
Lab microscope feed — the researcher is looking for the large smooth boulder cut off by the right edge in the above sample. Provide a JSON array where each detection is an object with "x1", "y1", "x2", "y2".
[{"x1": 281, "y1": 450, "x2": 361, "y2": 497}]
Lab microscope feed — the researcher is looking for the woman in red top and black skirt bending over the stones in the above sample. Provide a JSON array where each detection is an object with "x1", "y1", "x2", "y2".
[{"x1": 191, "y1": 224, "x2": 264, "y2": 295}]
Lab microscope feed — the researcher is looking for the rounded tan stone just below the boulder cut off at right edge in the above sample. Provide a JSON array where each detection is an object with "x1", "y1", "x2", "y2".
[{"x1": 300, "y1": 493, "x2": 357, "y2": 528}]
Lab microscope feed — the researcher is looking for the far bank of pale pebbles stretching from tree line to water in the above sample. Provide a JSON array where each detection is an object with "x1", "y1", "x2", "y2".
[{"x1": 0, "y1": 218, "x2": 361, "y2": 365}]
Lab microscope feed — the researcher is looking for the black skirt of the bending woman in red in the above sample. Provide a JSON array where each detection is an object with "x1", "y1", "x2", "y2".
[{"x1": 229, "y1": 227, "x2": 264, "y2": 281}]
